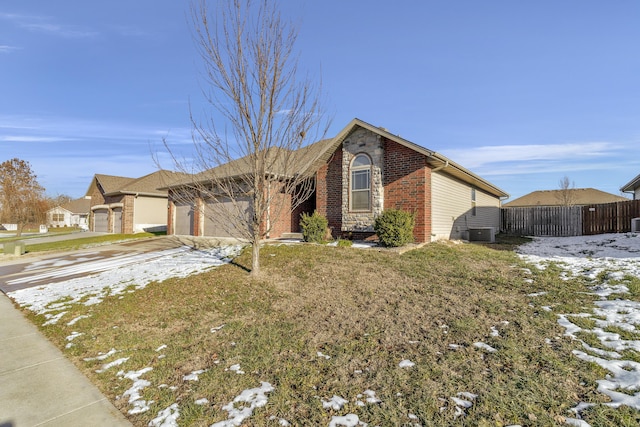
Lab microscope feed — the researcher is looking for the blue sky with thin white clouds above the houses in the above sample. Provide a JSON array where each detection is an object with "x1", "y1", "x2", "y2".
[{"x1": 0, "y1": 0, "x2": 640, "y2": 200}]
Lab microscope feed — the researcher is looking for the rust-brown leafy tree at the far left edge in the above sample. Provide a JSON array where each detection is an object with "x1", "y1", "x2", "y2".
[{"x1": 0, "y1": 158, "x2": 48, "y2": 236}]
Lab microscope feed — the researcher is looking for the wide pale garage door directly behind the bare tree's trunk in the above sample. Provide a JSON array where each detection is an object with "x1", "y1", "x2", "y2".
[{"x1": 204, "y1": 197, "x2": 251, "y2": 237}]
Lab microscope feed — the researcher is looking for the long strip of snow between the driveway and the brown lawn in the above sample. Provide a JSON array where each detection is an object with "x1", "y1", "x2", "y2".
[{"x1": 7, "y1": 246, "x2": 242, "y2": 325}]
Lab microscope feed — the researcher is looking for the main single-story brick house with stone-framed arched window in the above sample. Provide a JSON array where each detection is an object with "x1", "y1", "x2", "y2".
[{"x1": 168, "y1": 119, "x2": 508, "y2": 242}]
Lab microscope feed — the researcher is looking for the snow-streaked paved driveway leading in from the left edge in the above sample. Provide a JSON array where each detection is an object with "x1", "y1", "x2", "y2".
[{"x1": 0, "y1": 236, "x2": 185, "y2": 294}]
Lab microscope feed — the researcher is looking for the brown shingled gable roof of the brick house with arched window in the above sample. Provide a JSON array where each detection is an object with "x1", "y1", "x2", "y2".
[{"x1": 165, "y1": 118, "x2": 509, "y2": 198}]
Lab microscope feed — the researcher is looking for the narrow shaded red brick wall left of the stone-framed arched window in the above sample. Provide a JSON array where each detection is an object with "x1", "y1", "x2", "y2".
[{"x1": 316, "y1": 147, "x2": 342, "y2": 237}]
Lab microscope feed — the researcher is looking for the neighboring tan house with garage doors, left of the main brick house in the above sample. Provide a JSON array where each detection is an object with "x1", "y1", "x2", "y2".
[{"x1": 86, "y1": 170, "x2": 181, "y2": 234}]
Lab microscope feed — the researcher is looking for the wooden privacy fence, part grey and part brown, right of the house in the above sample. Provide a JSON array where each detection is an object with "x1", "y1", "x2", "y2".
[{"x1": 500, "y1": 200, "x2": 640, "y2": 237}]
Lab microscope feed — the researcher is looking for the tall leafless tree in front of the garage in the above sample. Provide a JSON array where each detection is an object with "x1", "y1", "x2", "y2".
[{"x1": 165, "y1": 0, "x2": 328, "y2": 275}]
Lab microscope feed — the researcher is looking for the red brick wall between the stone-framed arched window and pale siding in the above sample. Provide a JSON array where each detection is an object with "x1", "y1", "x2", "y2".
[{"x1": 383, "y1": 140, "x2": 431, "y2": 242}]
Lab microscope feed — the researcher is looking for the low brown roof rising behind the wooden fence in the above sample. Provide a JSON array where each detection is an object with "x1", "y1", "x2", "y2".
[{"x1": 503, "y1": 188, "x2": 629, "y2": 208}]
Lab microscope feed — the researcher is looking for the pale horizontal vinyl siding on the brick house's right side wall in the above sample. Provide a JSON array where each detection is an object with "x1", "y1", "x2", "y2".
[{"x1": 431, "y1": 172, "x2": 500, "y2": 240}]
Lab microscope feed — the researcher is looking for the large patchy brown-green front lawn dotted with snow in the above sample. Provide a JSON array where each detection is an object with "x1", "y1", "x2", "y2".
[{"x1": 17, "y1": 243, "x2": 637, "y2": 426}]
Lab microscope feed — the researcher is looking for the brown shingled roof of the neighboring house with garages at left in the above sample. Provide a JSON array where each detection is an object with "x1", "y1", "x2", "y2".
[{"x1": 95, "y1": 170, "x2": 186, "y2": 196}]
